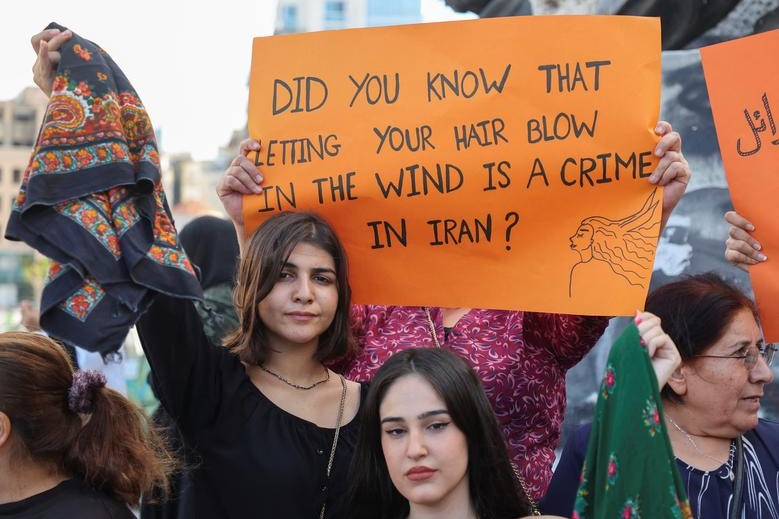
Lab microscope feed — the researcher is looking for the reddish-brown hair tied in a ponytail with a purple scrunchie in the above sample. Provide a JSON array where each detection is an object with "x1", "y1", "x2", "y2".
[{"x1": 0, "y1": 332, "x2": 176, "y2": 506}]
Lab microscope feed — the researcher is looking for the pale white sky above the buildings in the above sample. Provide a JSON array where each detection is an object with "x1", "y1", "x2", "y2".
[{"x1": 0, "y1": 0, "x2": 472, "y2": 160}]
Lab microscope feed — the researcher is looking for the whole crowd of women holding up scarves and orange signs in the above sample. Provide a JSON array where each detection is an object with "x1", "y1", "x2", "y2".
[{"x1": 0, "y1": 18, "x2": 779, "y2": 519}]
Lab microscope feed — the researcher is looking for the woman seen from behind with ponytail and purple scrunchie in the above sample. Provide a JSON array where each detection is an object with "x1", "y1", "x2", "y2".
[{"x1": 0, "y1": 332, "x2": 175, "y2": 519}]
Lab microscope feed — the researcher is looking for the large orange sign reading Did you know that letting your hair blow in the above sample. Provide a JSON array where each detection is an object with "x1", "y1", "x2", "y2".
[{"x1": 244, "y1": 16, "x2": 662, "y2": 315}]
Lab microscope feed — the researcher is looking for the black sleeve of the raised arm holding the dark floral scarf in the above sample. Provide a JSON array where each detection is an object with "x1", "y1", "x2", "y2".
[{"x1": 137, "y1": 295, "x2": 227, "y2": 434}]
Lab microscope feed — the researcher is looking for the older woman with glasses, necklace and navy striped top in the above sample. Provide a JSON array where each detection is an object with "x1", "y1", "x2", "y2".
[{"x1": 541, "y1": 273, "x2": 779, "y2": 519}]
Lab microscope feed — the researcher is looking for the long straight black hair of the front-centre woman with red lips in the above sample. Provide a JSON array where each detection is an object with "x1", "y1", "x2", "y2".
[{"x1": 349, "y1": 348, "x2": 529, "y2": 519}]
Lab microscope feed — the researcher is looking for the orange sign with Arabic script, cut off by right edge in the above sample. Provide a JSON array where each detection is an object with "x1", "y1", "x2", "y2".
[{"x1": 701, "y1": 30, "x2": 779, "y2": 342}]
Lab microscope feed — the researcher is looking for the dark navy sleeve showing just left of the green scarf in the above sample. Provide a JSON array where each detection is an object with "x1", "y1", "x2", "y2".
[{"x1": 539, "y1": 424, "x2": 591, "y2": 517}]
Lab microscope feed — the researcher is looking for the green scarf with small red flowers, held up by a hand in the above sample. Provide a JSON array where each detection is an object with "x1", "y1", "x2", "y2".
[{"x1": 572, "y1": 324, "x2": 692, "y2": 519}]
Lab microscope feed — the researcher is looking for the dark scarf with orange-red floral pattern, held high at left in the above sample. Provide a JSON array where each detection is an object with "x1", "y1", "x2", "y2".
[{"x1": 5, "y1": 23, "x2": 202, "y2": 353}]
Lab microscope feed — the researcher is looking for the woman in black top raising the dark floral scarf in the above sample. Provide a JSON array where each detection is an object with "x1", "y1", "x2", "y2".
[{"x1": 32, "y1": 25, "x2": 362, "y2": 519}]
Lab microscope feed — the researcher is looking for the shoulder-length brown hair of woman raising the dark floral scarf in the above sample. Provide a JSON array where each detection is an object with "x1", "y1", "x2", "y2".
[{"x1": 224, "y1": 212, "x2": 352, "y2": 364}]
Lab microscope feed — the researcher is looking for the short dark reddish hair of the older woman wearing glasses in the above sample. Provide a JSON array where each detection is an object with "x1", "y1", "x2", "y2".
[{"x1": 646, "y1": 272, "x2": 759, "y2": 401}]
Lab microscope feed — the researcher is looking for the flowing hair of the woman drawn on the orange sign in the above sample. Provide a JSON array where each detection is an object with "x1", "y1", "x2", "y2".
[{"x1": 580, "y1": 188, "x2": 660, "y2": 287}]
